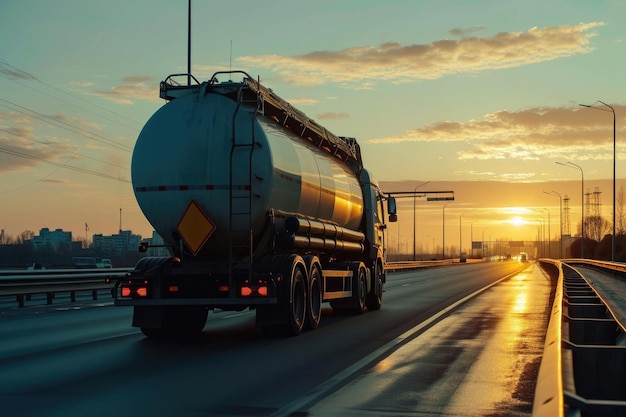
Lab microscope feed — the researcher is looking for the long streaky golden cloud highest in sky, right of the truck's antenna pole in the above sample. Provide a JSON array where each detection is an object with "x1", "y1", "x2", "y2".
[{"x1": 237, "y1": 22, "x2": 604, "y2": 88}]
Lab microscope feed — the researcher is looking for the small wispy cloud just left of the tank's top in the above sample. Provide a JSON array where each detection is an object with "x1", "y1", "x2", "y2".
[{"x1": 80, "y1": 75, "x2": 159, "y2": 105}]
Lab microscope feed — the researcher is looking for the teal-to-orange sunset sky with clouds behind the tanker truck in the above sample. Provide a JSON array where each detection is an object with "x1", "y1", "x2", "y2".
[{"x1": 0, "y1": 0, "x2": 626, "y2": 255}]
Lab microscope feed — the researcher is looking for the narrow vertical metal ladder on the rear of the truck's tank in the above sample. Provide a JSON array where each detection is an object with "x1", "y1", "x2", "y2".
[{"x1": 228, "y1": 83, "x2": 263, "y2": 288}]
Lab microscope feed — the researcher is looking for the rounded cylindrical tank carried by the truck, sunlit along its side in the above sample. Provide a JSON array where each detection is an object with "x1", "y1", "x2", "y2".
[{"x1": 131, "y1": 75, "x2": 363, "y2": 258}]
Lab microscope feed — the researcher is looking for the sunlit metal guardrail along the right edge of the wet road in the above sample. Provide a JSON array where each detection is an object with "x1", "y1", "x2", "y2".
[{"x1": 532, "y1": 259, "x2": 626, "y2": 417}]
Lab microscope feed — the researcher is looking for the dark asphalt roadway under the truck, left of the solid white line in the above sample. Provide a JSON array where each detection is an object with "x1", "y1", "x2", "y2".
[{"x1": 0, "y1": 262, "x2": 536, "y2": 417}]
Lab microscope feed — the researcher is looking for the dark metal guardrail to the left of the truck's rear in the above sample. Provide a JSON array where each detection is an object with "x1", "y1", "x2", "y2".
[{"x1": 0, "y1": 268, "x2": 131, "y2": 307}]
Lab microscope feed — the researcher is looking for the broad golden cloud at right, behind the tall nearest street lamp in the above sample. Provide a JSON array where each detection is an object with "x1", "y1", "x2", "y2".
[{"x1": 368, "y1": 105, "x2": 626, "y2": 160}]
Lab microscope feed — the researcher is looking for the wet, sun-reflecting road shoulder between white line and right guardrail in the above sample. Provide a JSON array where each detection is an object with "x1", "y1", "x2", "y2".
[{"x1": 306, "y1": 264, "x2": 551, "y2": 417}]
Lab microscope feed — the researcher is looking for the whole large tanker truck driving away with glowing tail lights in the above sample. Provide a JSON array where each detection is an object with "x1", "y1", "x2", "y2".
[{"x1": 113, "y1": 71, "x2": 396, "y2": 338}]
